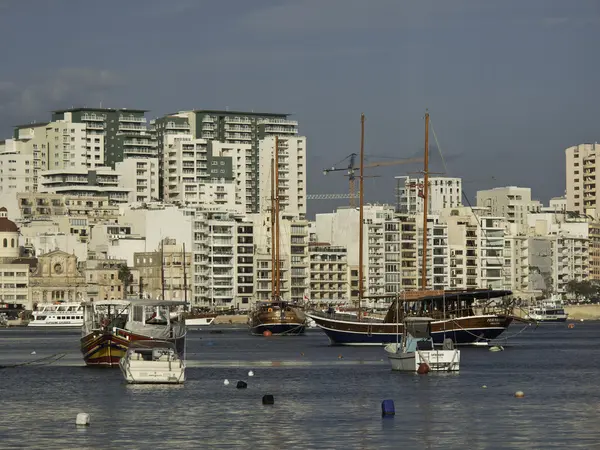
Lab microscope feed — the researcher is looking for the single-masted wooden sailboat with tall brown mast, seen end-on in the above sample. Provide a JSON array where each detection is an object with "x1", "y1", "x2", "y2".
[{"x1": 248, "y1": 136, "x2": 306, "y2": 336}]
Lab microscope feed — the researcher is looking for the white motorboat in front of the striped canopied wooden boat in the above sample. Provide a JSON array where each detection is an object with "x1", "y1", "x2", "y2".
[{"x1": 119, "y1": 340, "x2": 185, "y2": 384}]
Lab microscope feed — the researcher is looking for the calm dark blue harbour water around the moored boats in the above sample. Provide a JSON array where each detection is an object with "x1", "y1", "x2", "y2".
[{"x1": 0, "y1": 322, "x2": 600, "y2": 449}]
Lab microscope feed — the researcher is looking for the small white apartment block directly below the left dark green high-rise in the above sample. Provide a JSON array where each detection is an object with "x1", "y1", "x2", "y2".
[{"x1": 115, "y1": 158, "x2": 160, "y2": 203}]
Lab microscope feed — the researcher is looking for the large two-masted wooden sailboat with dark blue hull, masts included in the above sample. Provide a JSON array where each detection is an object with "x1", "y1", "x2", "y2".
[{"x1": 306, "y1": 113, "x2": 514, "y2": 345}]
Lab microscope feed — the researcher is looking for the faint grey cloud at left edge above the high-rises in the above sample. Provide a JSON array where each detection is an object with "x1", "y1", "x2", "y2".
[{"x1": 0, "y1": 67, "x2": 123, "y2": 133}]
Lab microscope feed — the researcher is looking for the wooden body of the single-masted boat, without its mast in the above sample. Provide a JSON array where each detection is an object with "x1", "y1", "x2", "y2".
[{"x1": 249, "y1": 301, "x2": 306, "y2": 336}]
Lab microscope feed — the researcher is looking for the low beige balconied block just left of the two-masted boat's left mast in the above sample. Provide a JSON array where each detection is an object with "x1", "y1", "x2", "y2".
[{"x1": 308, "y1": 242, "x2": 349, "y2": 303}]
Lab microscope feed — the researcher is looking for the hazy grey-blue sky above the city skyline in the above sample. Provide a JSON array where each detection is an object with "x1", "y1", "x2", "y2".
[{"x1": 0, "y1": 0, "x2": 600, "y2": 215}]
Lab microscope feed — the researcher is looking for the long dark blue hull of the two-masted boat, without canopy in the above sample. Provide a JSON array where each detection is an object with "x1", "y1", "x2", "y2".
[{"x1": 307, "y1": 314, "x2": 513, "y2": 346}]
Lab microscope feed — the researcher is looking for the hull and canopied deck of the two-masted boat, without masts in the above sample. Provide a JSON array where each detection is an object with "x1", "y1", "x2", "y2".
[{"x1": 306, "y1": 290, "x2": 514, "y2": 345}]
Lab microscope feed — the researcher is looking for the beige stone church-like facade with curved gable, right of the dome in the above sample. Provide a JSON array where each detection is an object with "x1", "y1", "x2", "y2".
[{"x1": 29, "y1": 250, "x2": 87, "y2": 305}]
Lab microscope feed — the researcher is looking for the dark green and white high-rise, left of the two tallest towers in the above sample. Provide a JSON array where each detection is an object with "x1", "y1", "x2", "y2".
[{"x1": 49, "y1": 108, "x2": 152, "y2": 169}]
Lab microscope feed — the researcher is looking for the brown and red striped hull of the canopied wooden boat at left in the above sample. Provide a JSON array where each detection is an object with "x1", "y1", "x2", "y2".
[{"x1": 80, "y1": 328, "x2": 185, "y2": 367}]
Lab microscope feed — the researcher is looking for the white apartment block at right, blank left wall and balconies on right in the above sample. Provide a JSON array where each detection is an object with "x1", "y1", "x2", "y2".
[{"x1": 528, "y1": 213, "x2": 590, "y2": 296}]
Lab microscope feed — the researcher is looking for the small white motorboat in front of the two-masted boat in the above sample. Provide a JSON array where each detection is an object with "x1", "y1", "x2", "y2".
[{"x1": 385, "y1": 317, "x2": 460, "y2": 372}]
